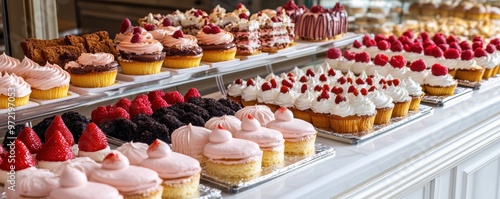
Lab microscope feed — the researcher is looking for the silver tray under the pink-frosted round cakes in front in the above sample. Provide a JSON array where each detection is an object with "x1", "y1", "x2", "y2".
[{"x1": 201, "y1": 143, "x2": 335, "y2": 194}]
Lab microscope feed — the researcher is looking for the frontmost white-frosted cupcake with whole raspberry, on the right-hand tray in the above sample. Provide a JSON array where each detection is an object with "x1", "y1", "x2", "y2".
[{"x1": 424, "y1": 64, "x2": 458, "y2": 96}]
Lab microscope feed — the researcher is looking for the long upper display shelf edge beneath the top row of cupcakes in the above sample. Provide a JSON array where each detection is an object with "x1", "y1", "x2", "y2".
[{"x1": 0, "y1": 33, "x2": 362, "y2": 131}]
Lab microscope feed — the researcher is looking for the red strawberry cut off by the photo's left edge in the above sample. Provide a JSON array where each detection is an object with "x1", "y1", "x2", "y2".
[{"x1": 0, "y1": 139, "x2": 36, "y2": 171}]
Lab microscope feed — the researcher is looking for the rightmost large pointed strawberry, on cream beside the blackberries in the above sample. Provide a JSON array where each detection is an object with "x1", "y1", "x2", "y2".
[{"x1": 78, "y1": 122, "x2": 108, "y2": 152}]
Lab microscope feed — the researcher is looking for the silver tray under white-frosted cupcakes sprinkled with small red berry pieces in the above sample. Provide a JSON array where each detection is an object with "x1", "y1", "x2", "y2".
[{"x1": 316, "y1": 105, "x2": 434, "y2": 144}]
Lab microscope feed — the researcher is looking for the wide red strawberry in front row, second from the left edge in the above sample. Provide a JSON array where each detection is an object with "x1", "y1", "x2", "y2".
[{"x1": 36, "y1": 130, "x2": 75, "y2": 162}]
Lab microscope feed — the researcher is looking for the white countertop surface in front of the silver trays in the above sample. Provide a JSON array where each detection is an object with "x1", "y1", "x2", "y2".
[{"x1": 223, "y1": 81, "x2": 500, "y2": 199}]
